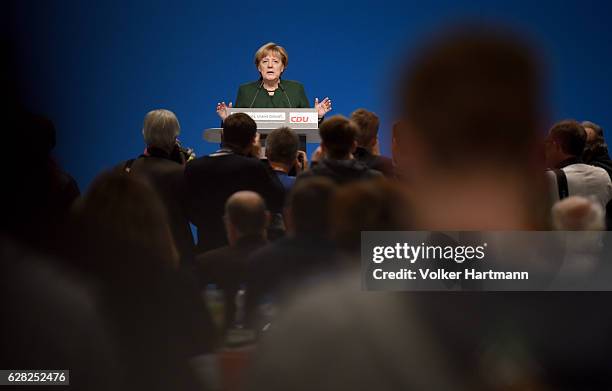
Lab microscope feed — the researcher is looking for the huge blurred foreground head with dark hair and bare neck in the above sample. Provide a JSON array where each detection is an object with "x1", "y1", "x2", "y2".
[{"x1": 392, "y1": 29, "x2": 545, "y2": 229}]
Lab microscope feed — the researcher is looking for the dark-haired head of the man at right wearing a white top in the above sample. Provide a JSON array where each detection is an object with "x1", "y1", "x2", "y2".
[{"x1": 544, "y1": 120, "x2": 586, "y2": 168}]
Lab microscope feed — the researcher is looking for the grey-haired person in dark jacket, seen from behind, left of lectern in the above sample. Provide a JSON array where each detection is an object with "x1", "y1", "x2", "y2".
[{"x1": 117, "y1": 109, "x2": 194, "y2": 263}]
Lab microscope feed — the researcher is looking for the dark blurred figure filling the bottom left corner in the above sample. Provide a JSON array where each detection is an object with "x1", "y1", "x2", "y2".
[{"x1": 0, "y1": 240, "x2": 116, "y2": 391}]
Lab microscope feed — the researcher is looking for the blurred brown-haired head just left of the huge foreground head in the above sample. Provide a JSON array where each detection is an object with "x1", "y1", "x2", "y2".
[{"x1": 330, "y1": 179, "x2": 411, "y2": 253}]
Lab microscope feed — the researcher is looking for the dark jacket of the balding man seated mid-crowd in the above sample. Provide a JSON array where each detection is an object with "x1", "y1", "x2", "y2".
[{"x1": 195, "y1": 236, "x2": 267, "y2": 329}]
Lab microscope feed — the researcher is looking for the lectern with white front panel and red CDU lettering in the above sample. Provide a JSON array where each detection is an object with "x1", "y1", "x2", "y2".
[{"x1": 202, "y1": 107, "x2": 321, "y2": 150}]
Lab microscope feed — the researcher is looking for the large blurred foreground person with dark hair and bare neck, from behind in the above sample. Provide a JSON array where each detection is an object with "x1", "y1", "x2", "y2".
[{"x1": 246, "y1": 30, "x2": 612, "y2": 390}]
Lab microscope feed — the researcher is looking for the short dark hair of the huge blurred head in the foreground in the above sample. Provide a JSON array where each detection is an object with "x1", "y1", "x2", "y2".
[{"x1": 396, "y1": 27, "x2": 542, "y2": 167}]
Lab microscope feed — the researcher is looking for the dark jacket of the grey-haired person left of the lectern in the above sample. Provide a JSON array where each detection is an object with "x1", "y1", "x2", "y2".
[{"x1": 117, "y1": 148, "x2": 194, "y2": 263}]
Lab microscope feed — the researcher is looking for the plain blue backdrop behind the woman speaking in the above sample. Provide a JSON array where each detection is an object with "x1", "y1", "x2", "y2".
[{"x1": 10, "y1": 0, "x2": 612, "y2": 189}]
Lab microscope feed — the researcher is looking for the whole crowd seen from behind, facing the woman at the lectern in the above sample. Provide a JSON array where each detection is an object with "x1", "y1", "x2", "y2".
[{"x1": 2, "y1": 28, "x2": 612, "y2": 390}]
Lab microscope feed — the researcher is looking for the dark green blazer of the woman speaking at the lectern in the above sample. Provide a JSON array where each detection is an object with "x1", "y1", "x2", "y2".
[{"x1": 234, "y1": 80, "x2": 313, "y2": 109}]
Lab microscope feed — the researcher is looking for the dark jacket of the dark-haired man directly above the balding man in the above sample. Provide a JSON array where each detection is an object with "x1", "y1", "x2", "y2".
[{"x1": 185, "y1": 153, "x2": 285, "y2": 252}]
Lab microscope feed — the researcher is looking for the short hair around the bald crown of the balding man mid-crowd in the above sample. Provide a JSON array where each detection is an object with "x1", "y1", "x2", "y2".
[{"x1": 225, "y1": 192, "x2": 267, "y2": 235}]
